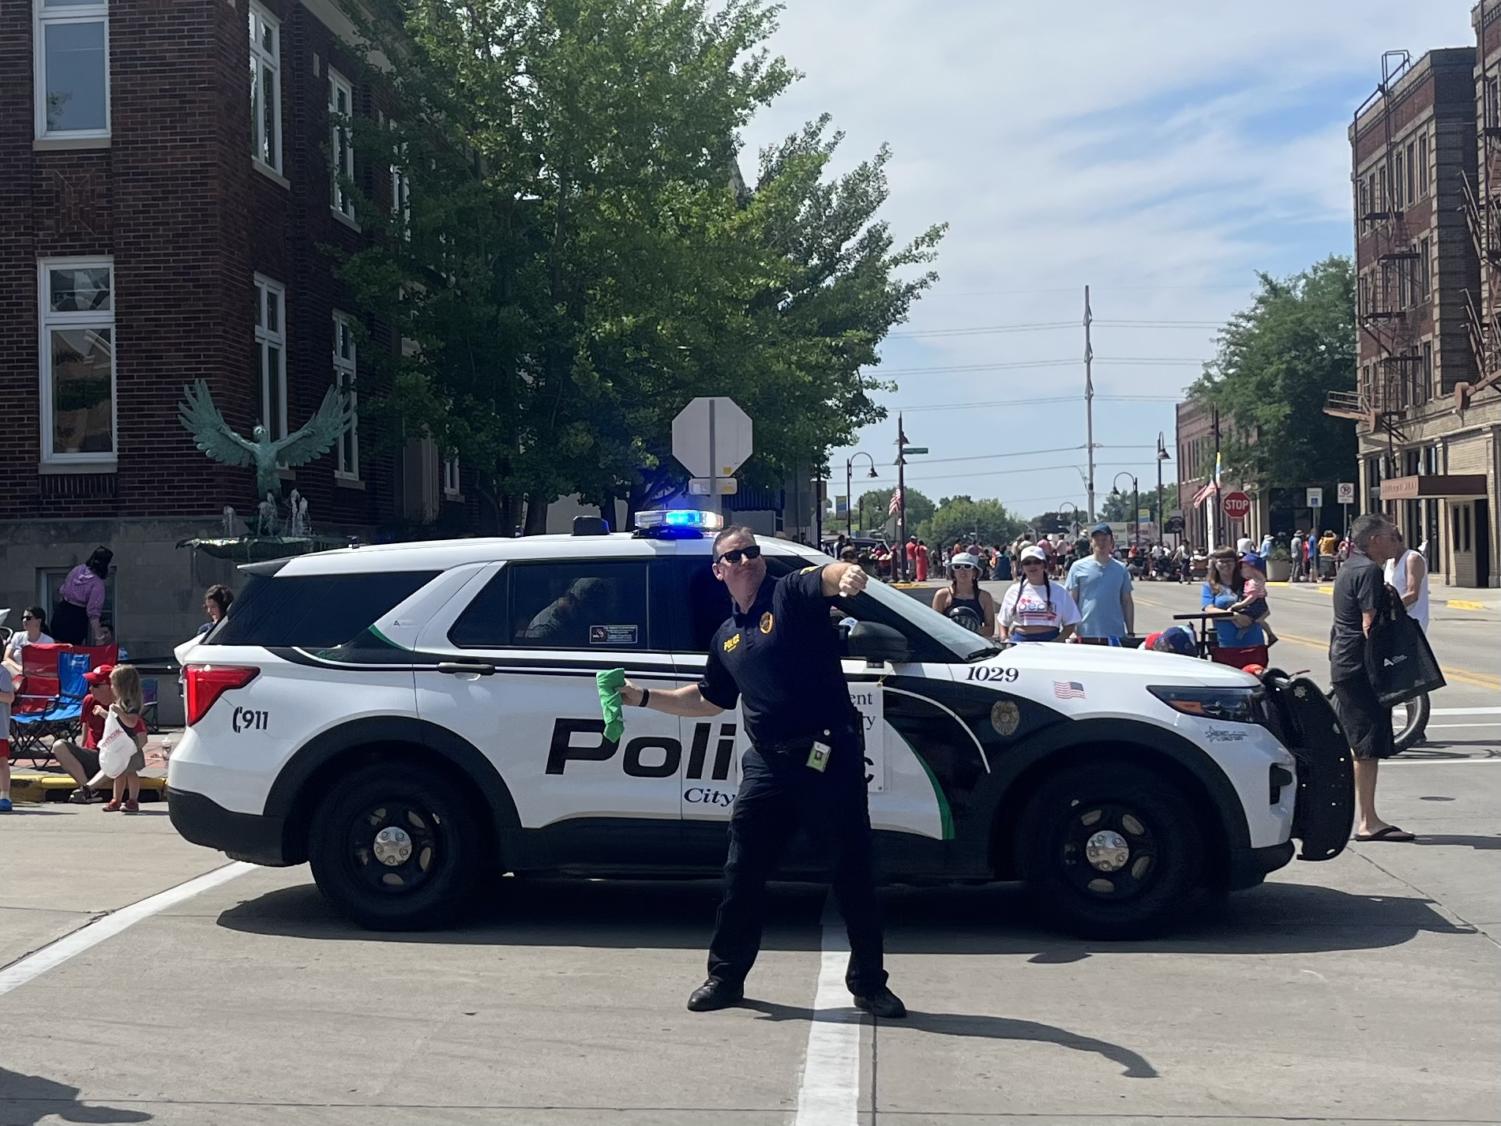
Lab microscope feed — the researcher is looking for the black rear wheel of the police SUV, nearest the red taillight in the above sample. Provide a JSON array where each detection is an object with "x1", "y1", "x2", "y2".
[{"x1": 308, "y1": 763, "x2": 480, "y2": 931}]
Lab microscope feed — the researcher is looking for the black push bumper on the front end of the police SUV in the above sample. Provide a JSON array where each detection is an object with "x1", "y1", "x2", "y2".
[{"x1": 1265, "y1": 670, "x2": 1355, "y2": 860}]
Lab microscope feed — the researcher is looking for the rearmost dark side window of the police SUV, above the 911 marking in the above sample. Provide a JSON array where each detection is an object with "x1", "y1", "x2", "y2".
[{"x1": 203, "y1": 571, "x2": 438, "y2": 649}]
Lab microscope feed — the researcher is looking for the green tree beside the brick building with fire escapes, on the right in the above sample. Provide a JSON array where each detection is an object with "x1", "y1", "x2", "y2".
[{"x1": 1189, "y1": 255, "x2": 1357, "y2": 488}]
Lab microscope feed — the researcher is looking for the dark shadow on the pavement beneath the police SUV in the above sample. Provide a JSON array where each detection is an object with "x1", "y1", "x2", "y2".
[{"x1": 218, "y1": 878, "x2": 1469, "y2": 964}]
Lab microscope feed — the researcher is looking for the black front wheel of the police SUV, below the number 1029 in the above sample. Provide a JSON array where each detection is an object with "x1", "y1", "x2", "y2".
[{"x1": 1016, "y1": 763, "x2": 1204, "y2": 940}]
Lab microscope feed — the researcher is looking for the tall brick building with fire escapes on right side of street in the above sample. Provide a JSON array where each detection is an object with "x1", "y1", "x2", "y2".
[{"x1": 1325, "y1": 41, "x2": 1501, "y2": 586}]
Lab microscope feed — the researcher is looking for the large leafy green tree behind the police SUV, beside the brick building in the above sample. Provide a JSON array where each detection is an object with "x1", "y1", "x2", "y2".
[{"x1": 344, "y1": 0, "x2": 941, "y2": 530}]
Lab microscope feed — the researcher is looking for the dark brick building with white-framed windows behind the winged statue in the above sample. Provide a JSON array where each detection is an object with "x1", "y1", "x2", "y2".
[{"x1": 0, "y1": 0, "x2": 467, "y2": 675}]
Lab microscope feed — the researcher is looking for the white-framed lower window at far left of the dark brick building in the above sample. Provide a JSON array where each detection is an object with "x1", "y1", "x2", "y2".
[{"x1": 38, "y1": 258, "x2": 116, "y2": 464}]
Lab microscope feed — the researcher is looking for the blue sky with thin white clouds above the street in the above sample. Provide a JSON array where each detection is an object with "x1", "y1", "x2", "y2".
[{"x1": 741, "y1": 0, "x2": 1474, "y2": 528}]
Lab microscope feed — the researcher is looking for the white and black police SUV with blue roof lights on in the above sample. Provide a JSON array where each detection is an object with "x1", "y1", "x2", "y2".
[{"x1": 168, "y1": 513, "x2": 1351, "y2": 937}]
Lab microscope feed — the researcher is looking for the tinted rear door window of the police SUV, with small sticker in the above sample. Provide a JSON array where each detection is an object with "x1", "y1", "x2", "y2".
[{"x1": 449, "y1": 560, "x2": 650, "y2": 650}]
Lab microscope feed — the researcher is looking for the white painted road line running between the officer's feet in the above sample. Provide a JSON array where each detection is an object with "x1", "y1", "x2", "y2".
[{"x1": 793, "y1": 902, "x2": 862, "y2": 1126}]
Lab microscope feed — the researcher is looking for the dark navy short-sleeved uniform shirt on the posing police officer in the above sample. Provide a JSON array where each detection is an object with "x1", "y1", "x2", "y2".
[{"x1": 698, "y1": 568, "x2": 860, "y2": 748}]
